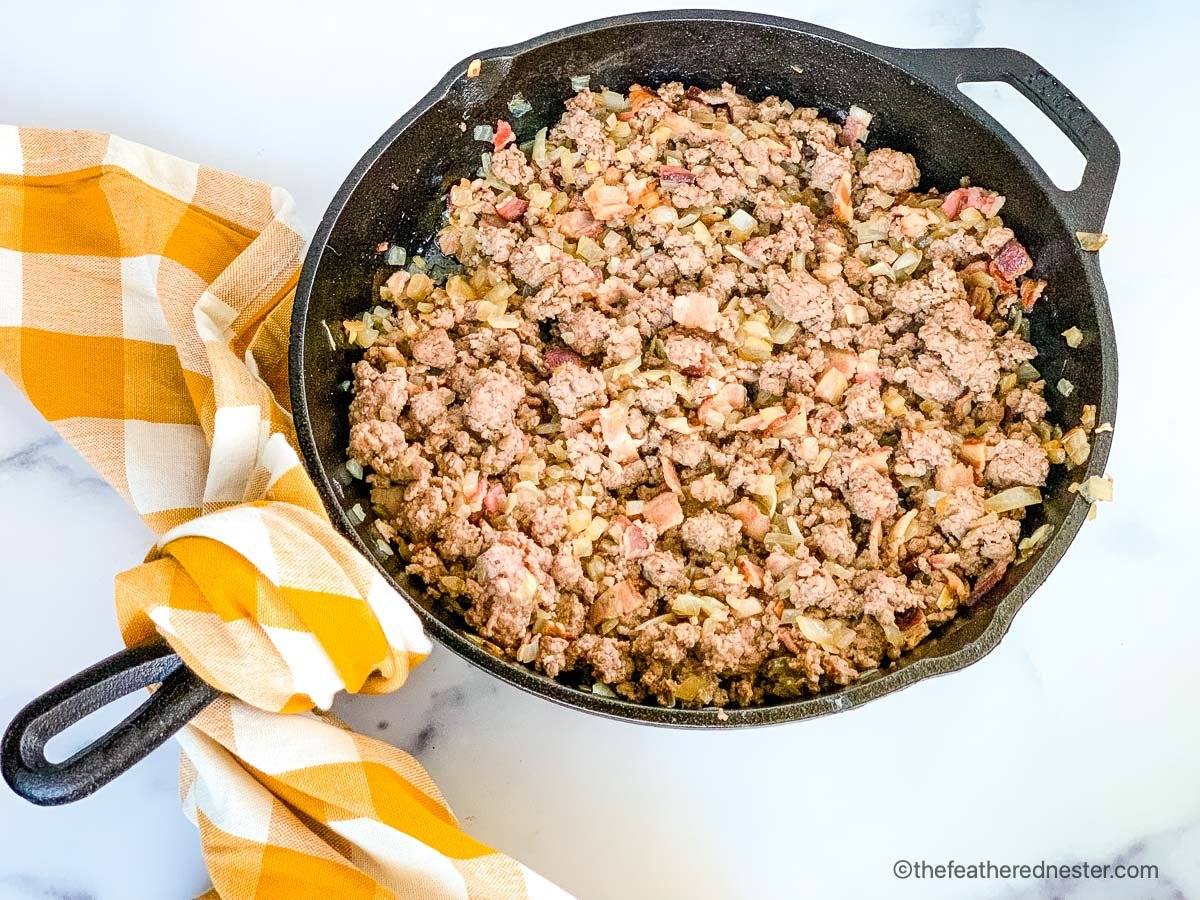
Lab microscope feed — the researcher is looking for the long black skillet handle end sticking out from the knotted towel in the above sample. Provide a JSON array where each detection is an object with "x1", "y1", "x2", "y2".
[{"x1": 0, "y1": 642, "x2": 220, "y2": 806}]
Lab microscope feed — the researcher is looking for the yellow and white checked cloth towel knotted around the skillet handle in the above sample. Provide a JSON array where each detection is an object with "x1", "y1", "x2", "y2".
[{"x1": 0, "y1": 126, "x2": 565, "y2": 900}]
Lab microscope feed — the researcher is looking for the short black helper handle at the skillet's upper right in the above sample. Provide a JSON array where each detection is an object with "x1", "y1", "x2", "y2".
[{"x1": 899, "y1": 47, "x2": 1121, "y2": 232}]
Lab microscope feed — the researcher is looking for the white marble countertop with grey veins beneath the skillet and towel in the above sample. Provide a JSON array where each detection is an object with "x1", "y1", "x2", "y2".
[{"x1": 0, "y1": 0, "x2": 1200, "y2": 900}]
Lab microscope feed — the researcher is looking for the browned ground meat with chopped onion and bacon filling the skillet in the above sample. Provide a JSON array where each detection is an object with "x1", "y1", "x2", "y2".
[{"x1": 347, "y1": 84, "x2": 1094, "y2": 707}]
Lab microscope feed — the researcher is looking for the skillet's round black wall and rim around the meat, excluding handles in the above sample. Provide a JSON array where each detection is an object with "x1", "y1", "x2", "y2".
[{"x1": 290, "y1": 12, "x2": 1116, "y2": 726}]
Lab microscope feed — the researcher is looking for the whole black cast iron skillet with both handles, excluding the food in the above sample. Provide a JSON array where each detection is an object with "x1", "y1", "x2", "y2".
[{"x1": 0, "y1": 11, "x2": 1118, "y2": 804}]
